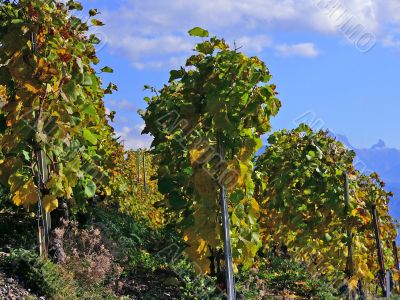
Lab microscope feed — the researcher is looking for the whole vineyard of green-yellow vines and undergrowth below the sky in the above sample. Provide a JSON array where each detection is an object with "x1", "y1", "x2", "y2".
[{"x1": 0, "y1": 0, "x2": 400, "y2": 300}]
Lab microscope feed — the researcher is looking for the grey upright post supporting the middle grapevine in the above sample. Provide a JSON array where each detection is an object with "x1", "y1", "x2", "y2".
[{"x1": 217, "y1": 132, "x2": 236, "y2": 300}]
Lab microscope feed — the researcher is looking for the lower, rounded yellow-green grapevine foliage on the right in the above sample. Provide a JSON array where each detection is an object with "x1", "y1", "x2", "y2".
[{"x1": 254, "y1": 125, "x2": 396, "y2": 288}]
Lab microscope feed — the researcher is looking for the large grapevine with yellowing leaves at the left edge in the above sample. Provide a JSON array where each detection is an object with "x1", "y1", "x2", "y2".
[{"x1": 0, "y1": 0, "x2": 116, "y2": 212}]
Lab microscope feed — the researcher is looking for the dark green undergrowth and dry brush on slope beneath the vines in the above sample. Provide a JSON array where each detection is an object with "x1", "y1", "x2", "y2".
[{"x1": 0, "y1": 207, "x2": 337, "y2": 300}]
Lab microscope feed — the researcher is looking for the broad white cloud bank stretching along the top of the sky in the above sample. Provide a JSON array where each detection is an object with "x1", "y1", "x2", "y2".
[{"x1": 92, "y1": 0, "x2": 400, "y2": 69}]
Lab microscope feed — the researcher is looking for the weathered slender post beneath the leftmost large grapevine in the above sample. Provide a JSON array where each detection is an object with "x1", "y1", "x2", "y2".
[{"x1": 37, "y1": 148, "x2": 51, "y2": 258}]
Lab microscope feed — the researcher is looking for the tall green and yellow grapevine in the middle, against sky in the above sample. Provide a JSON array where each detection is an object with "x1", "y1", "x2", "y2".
[{"x1": 143, "y1": 27, "x2": 280, "y2": 272}]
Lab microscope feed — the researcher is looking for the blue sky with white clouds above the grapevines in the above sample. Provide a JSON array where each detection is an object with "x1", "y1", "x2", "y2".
[{"x1": 82, "y1": 0, "x2": 400, "y2": 148}]
